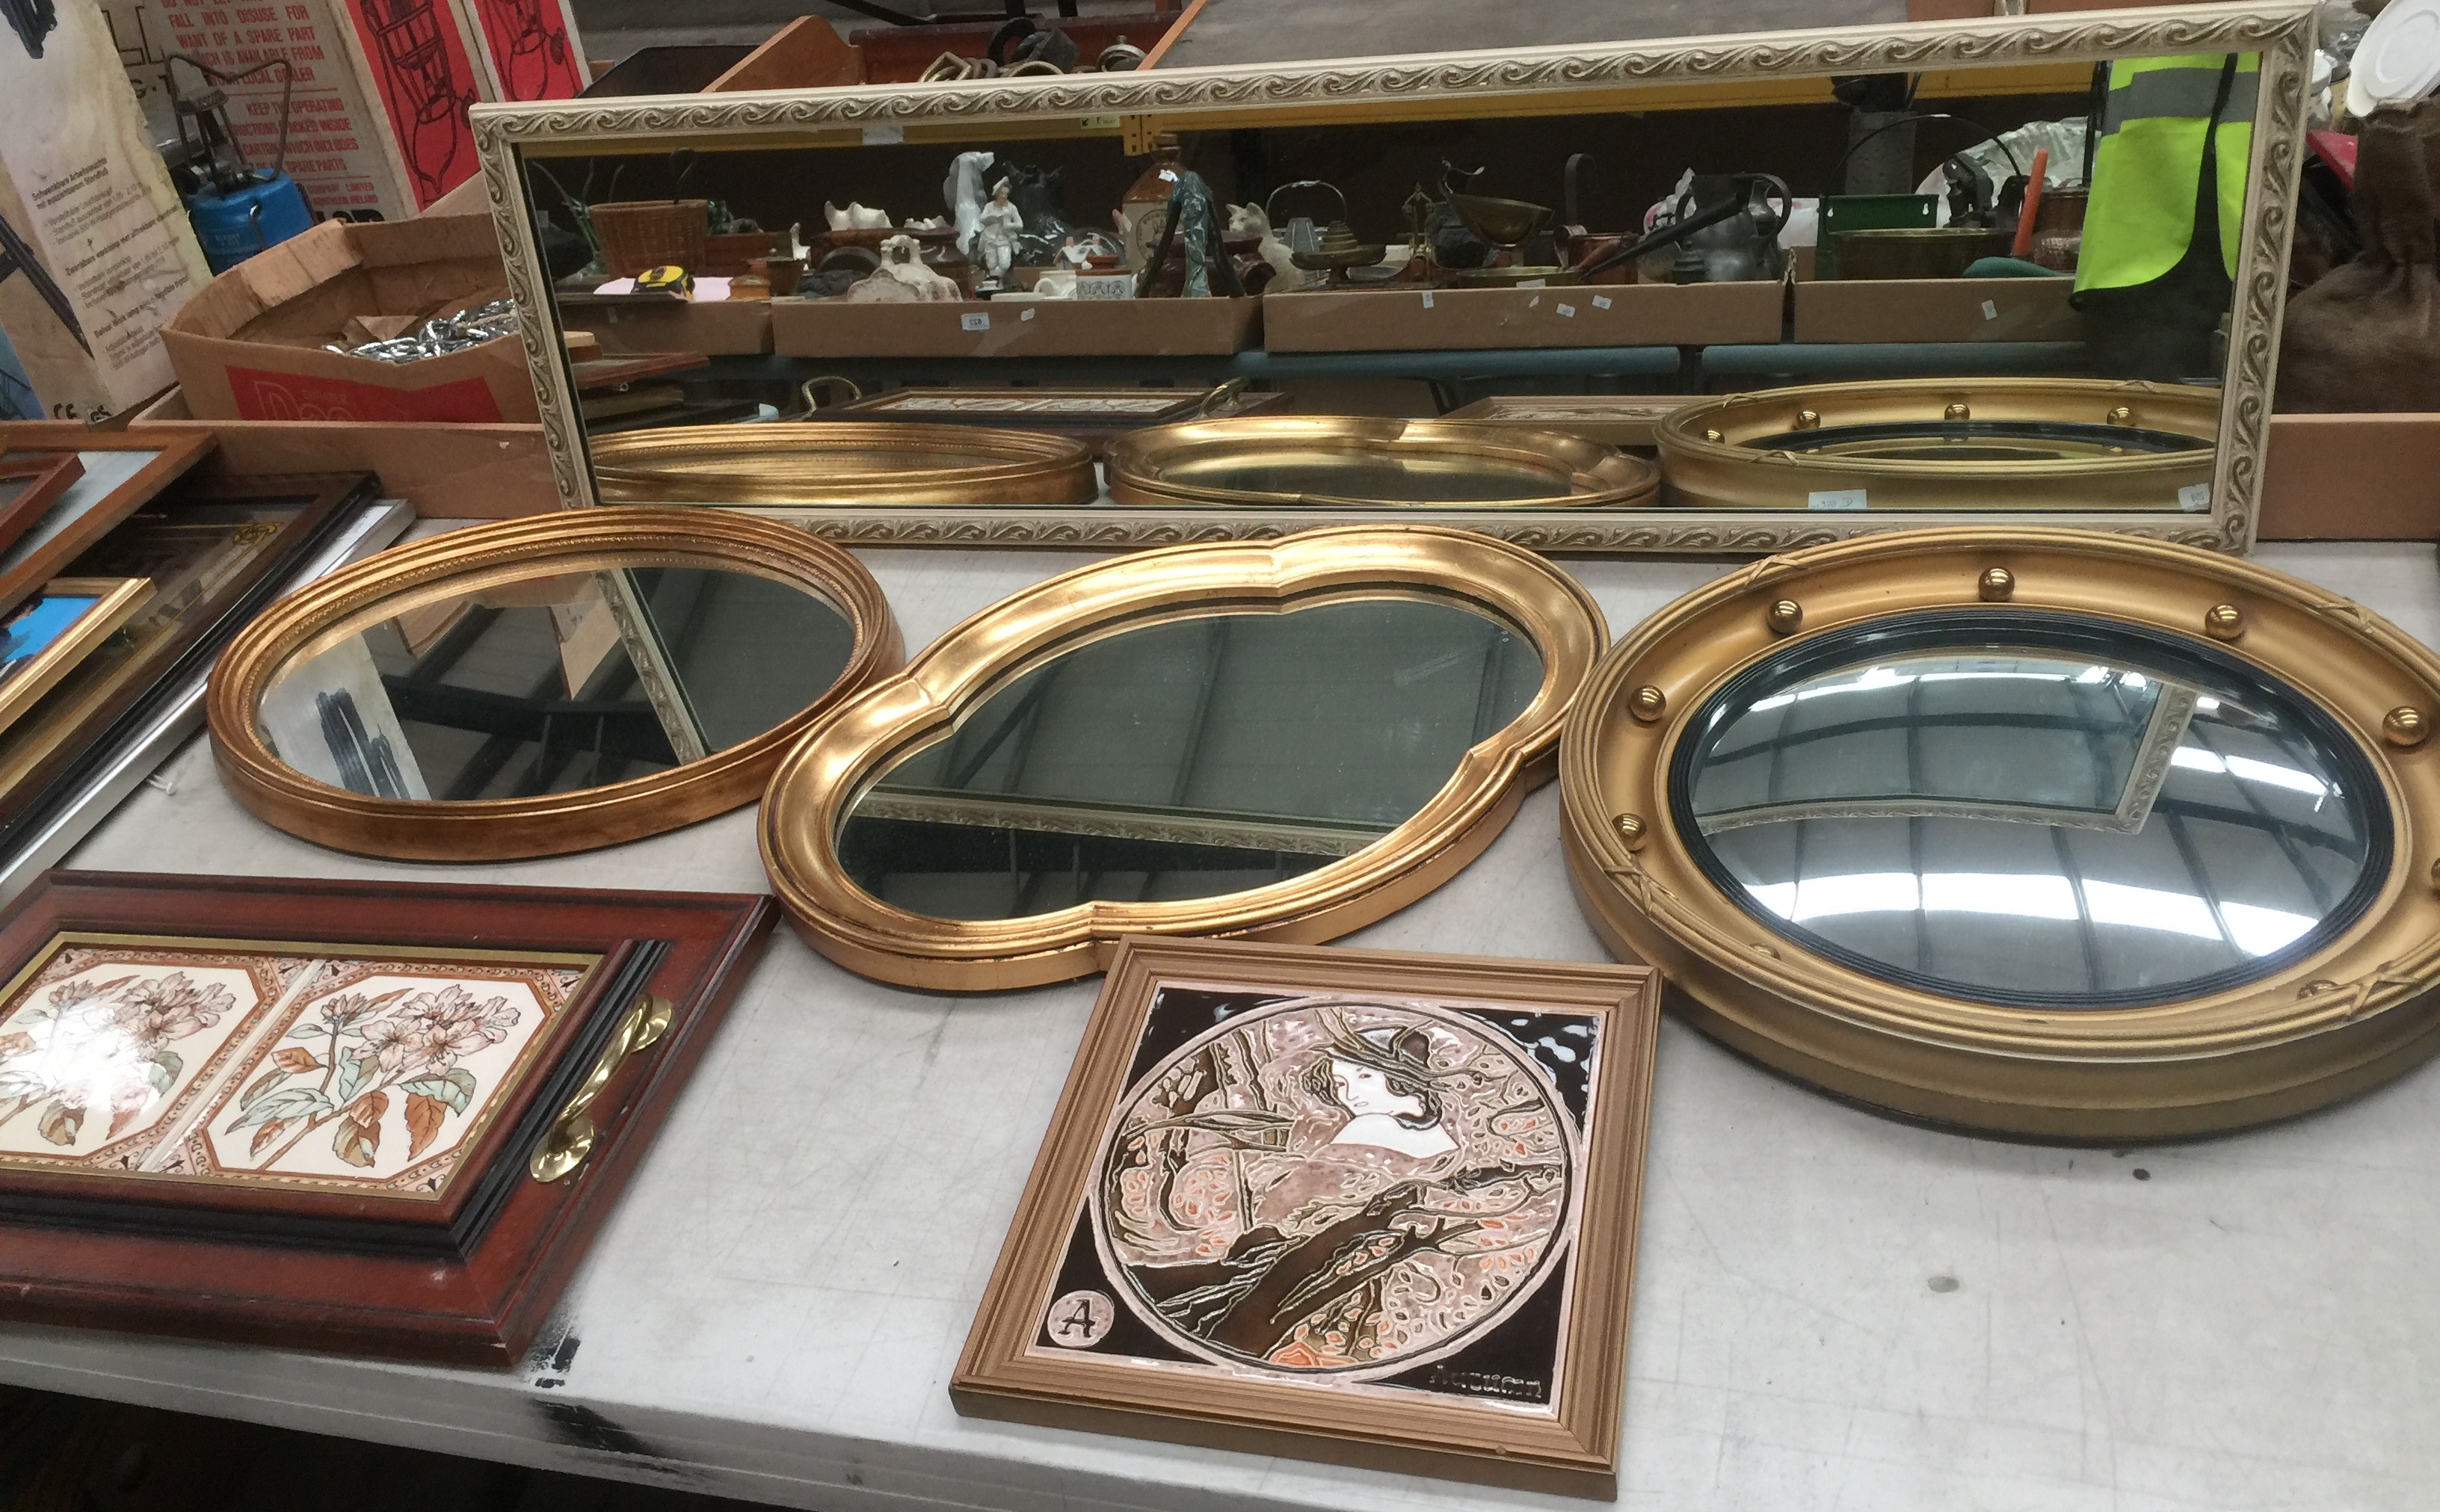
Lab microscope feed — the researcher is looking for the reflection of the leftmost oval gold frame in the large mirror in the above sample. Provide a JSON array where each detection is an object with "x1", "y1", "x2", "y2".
[{"x1": 588, "y1": 419, "x2": 1100, "y2": 504}]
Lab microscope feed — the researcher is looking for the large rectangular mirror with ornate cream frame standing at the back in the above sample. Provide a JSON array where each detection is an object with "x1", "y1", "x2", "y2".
[{"x1": 475, "y1": 2, "x2": 2313, "y2": 554}]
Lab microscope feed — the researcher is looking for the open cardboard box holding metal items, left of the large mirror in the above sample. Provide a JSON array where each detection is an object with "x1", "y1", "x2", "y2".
[{"x1": 161, "y1": 215, "x2": 542, "y2": 425}]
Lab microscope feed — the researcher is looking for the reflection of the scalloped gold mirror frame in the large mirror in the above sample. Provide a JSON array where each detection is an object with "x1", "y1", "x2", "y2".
[{"x1": 1106, "y1": 415, "x2": 1660, "y2": 510}]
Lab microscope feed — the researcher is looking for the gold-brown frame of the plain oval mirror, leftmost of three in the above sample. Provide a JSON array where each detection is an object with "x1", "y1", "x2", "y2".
[{"x1": 205, "y1": 507, "x2": 903, "y2": 861}]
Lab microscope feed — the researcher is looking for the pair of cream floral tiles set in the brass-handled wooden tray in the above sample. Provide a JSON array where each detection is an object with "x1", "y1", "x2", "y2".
[{"x1": 0, "y1": 934, "x2": 598, "y2": 1197}]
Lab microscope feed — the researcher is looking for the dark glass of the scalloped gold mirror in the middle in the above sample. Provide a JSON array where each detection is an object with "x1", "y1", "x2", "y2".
[{"x1": 839, "y1": 597, "x2": 1542, "y2": 919}]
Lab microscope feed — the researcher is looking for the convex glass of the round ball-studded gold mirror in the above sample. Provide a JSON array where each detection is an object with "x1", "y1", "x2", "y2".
[{"x1": 1672, "y1": 610, "x2": 2391, "y2": 1008}]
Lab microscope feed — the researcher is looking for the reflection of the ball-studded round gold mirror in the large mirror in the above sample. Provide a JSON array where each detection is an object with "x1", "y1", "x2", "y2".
[{"x1": 1657, "y1": 378, "x2": 2220, "y2": 514}]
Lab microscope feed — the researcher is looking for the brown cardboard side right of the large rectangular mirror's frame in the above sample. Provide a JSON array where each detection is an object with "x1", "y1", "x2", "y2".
[{"x1": 2255, "y1": 415, "x2": 2440, "y2": 541}]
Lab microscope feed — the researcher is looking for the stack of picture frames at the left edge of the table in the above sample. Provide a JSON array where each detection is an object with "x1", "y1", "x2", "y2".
[{"x1": 0, "y1": 422, "x2": 410, "y2": 900}]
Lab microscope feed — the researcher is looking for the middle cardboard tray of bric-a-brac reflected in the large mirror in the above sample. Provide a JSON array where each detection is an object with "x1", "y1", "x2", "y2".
[{"x1": 1261, "y1": 280, "x2": 1784, "y2": 351}]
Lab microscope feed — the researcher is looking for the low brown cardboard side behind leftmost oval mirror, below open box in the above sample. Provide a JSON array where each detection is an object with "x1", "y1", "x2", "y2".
[{"x1": 127, "y1": 388, "x2": 558, "y2": 519}]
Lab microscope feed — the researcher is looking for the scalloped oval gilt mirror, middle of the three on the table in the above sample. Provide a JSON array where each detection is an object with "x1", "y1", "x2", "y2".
[{"x1": 764, "y1": 527, "x2": 1606, "y2": 987}]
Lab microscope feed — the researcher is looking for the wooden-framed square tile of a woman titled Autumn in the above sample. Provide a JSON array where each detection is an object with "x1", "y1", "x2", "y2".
[{"x1": 952, "y1": 939, "x2": 1660, "y2": 1497}]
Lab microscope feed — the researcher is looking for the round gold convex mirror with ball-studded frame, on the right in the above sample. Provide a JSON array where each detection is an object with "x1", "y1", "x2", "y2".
[{"x1": 1559, "y1": 527, "x2": 2440, "y2": 1141}]
